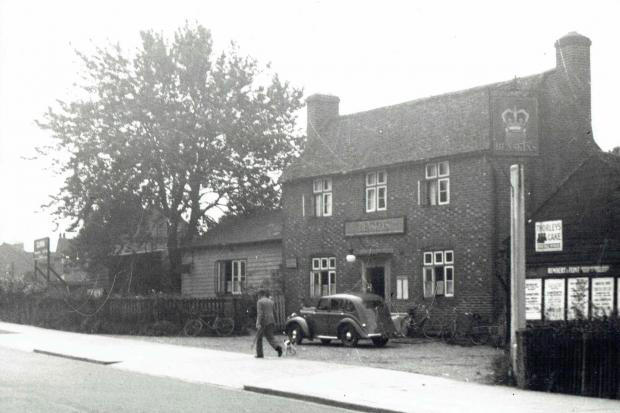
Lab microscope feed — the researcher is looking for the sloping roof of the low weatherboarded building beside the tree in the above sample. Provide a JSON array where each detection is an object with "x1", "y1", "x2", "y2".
[{"x1": 191, "y1": 210, "x2": 283, "y2": 247}]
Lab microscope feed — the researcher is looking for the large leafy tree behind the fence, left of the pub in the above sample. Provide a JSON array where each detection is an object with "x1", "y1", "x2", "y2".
[{"x1": 39, "y1": 24, "x2": 302, "y2": 289}]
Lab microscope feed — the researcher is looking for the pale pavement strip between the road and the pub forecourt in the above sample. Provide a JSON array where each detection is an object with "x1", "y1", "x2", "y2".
[{"x1": 0, "y1": 322, "x2": 620, "y2": 413}]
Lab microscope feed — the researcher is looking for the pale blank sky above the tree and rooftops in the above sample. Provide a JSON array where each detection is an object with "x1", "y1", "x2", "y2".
[{"x1": 0, "y1": 0, "x2": 620, "y2": 250}]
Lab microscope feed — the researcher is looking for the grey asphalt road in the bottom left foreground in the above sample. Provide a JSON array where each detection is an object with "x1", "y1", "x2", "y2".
[{"x1": 0, "y1": 347, "x2": 350, "y2": 413}]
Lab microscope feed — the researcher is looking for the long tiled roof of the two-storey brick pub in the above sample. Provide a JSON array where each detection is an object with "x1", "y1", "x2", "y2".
[{"x1": 282, "y1": 70, "x2": 553, "y2": 181}]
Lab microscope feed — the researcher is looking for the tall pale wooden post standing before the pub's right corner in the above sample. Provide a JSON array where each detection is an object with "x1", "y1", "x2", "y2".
[{"x1": 510, "y1": 164, "x2": 525, "y2": 384}]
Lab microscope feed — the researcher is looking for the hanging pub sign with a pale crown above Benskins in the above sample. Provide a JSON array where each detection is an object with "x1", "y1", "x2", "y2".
[{"x1": 492, "y1": 96, "x2": 538, "y2": 155}]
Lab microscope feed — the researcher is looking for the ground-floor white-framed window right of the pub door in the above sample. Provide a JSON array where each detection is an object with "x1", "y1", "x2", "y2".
[{"x1": 422, "y1": 250, "x2": 454, "y2": 297}]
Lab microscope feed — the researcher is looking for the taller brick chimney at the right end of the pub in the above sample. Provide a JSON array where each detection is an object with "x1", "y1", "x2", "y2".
[{"x1": 555, "y1": 32, "x2": 592, "y2": 121}]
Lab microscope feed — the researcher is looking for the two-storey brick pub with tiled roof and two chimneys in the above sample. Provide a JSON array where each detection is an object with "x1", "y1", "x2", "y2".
[{"x1": 282, "y1": 33, "x2": 600, "y2": 319}]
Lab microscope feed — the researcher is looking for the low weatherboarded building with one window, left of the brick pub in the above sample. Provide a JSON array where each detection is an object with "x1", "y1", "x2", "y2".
[{"x1": 182, "y1": 211, "x2": 282, "y2": 298}]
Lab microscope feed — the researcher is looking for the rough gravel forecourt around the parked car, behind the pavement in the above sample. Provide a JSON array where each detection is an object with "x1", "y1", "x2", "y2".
[{"x1": 115, "y1": 335, "x2": 503, "y2": 384}]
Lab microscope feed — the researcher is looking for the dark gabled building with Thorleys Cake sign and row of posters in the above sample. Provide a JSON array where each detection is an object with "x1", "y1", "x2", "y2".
[{"x1": 526, "y1": 153, "x2": 620, "y2": 323}]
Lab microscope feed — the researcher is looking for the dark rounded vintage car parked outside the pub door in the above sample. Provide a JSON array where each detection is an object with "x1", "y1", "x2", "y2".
[{"x1": 285, "y1": 293, "x2": 396, "y2": 347}]
